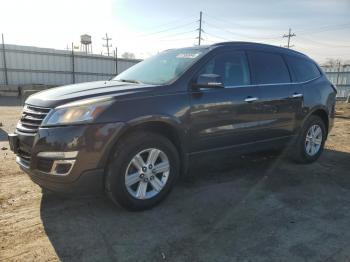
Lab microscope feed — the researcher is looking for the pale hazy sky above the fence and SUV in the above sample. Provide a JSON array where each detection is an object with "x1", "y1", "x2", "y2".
[{"x1": 0, "y1": 0, "x2": 350, "y2": 63}]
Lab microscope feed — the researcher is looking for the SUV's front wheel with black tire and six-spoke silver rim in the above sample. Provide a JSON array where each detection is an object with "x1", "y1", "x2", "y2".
[{"x1": 105, "y1": 132, "x2": 179, "y2": 211}]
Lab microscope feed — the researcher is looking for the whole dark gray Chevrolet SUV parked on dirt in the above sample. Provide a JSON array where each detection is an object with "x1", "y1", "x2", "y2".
[{"x1": 9, "y1": 42, "x2": 336, "y2": 210}]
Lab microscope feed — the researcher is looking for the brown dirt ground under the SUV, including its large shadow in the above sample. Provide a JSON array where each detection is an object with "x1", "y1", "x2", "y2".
[{"x1": 0, "y1": 103, "x2": 350, "y2": 261}]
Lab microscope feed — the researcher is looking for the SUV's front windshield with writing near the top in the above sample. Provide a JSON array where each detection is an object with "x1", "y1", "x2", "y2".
[{"x1": 113, "y1": 48, "x2": 207, "y2": 85}]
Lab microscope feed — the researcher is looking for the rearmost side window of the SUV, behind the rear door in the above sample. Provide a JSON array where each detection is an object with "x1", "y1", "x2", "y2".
[{"x1": 286, "y1": 56, "x2": 321, "y2": 82}]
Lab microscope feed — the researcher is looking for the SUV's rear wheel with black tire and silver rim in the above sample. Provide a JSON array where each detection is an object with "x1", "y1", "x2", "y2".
[{"x1": 291, "y1": 115, "x2": 327, "y2": 163}]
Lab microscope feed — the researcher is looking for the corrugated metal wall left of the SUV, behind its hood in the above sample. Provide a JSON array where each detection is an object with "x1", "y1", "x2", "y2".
[{"x1": 0, "y1": 45, "x2": 140, "y2": 85}]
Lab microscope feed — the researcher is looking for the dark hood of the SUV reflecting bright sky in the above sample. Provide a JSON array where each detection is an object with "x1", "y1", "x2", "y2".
[{"x1": 26, "y1": 81, "x2": 157, "y2": 108}]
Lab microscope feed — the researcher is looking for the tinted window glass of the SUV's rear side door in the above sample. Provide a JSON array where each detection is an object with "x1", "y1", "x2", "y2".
[{"x1": 249, "y1": 51, "x2": 290, "y2": 84}]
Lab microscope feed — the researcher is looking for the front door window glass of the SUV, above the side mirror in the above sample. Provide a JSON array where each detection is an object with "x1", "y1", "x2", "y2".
[{"x1": 199, "y1": 52, "x2": 250, "y2": 87}]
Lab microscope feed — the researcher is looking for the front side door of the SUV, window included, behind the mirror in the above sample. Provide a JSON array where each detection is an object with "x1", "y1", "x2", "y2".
[{"x1": 190, "y1": 51, "x2": 261, "y2": 152}]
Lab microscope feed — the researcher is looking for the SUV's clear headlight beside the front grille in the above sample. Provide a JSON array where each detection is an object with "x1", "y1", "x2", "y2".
[{"x1": 42, "y1": 97, "x2": 113, "y2": 126}]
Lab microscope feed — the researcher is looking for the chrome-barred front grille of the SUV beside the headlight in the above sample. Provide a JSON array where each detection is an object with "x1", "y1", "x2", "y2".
[{"x1": 16, "y1": 105, "x2": 50, "y2": 134}]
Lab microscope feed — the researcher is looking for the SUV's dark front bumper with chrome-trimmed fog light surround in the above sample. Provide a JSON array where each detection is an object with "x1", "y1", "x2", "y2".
[{"x1": 9, "y1": 122, "x2": 124, "y2": 193}]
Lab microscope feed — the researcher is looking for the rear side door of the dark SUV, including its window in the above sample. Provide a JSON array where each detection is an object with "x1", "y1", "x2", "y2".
[{"x1": 248, "y1": 51, "x2": 303, "y2": 139}]
